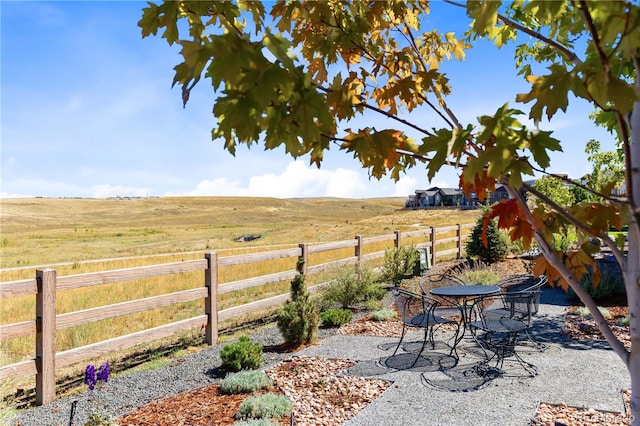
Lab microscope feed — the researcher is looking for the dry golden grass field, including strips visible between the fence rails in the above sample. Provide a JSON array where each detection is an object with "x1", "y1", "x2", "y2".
[{"x1": 0, "y1": 197, "x2": 479, "y2": 372}]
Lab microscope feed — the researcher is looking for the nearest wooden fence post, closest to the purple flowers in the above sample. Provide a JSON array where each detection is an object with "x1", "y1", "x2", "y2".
[{"x1": 36, "y1": 269, "x2": 56, "y2": 405}]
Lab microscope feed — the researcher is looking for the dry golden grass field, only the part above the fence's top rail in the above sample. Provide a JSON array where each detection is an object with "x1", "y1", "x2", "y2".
[{"x1": 0, "y1": 197, "x2": 478, "y2": 270}]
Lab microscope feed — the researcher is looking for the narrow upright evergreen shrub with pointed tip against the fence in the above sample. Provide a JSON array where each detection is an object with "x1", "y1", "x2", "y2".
[{"x1": 277, "y1": 274, "x2": 320, "y2": 347}]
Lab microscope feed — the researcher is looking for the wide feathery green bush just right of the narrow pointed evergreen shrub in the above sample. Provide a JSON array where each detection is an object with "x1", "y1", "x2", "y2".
[{"x1": 321, "y1": 266, "x2": 386, "y2": 309}]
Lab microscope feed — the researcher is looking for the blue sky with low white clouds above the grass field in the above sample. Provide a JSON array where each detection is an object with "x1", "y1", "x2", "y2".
[{"x1": 0, "y1": 1, "x2": 613, "y2": 198}]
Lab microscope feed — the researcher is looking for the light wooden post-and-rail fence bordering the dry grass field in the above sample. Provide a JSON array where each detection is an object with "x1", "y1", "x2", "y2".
[{"x1": 0, "y1": 224, "x2": 473, "y2": 405}]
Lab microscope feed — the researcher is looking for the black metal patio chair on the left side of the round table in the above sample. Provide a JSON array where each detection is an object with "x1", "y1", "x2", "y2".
[{"x1": 392, "y1": 287, "x2": 460, "y2": 367}]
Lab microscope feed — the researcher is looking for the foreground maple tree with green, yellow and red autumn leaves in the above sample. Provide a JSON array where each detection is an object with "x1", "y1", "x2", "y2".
[{"x1": 139, "y1": 0, "x2": 640, "y2": 419}]
